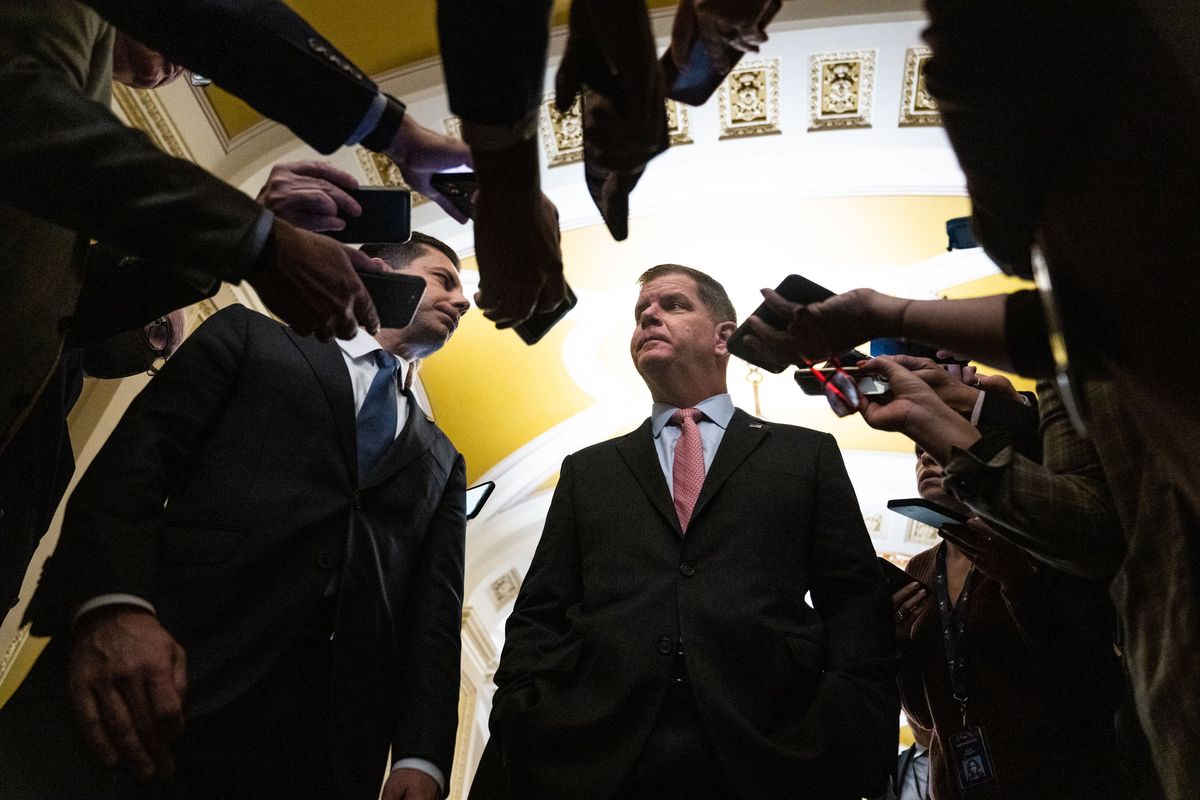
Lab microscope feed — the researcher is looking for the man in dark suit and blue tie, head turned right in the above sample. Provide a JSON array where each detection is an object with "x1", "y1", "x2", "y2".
[{"x1": 0, "y1": 234, "x2": 477, "y2": 800}]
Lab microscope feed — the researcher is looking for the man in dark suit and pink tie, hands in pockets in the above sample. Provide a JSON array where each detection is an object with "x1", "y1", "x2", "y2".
[{"x1": 473, "y1": 265, "x2": 899, "y2": 800}]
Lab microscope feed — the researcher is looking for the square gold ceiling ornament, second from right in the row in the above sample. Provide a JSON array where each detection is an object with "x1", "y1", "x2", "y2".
[{"x1": 809, "y1": 50, "x2": 875, "y2": 131}]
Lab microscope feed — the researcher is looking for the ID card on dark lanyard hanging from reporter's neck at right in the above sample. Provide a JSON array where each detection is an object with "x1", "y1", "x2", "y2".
[{"x1": 935, "y1": 542, "x2": 997, "y2": 800}]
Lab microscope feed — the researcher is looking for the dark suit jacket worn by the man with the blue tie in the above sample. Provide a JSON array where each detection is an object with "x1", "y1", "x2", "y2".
[{"x1": 19, "y1": 306, "x2": 466, "y2": 798}]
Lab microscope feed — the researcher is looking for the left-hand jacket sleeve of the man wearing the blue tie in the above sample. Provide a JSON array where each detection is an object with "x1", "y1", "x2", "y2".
[{"x1": 28, "y1": 306, "x2": 252, "y2": 636}]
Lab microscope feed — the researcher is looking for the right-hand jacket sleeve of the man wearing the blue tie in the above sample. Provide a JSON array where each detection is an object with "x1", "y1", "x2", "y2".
[{"x1": 391, "y1": 456, "x2": 467, "y2": 786}]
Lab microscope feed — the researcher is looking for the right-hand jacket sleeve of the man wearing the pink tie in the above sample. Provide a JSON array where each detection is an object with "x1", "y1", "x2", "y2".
[{"x1": 810, "y1": 434, "x2": 900, "y2": 795}]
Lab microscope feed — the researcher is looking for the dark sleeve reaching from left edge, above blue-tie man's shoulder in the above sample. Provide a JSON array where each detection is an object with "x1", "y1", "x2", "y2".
[{"x1": 0, "y1": 56, "x2": 272, "y2": 281}]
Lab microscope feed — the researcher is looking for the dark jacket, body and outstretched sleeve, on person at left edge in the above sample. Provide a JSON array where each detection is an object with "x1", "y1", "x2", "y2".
[{"x1": 0, "y1": 0, "x2": 270, "y2": 451}]
